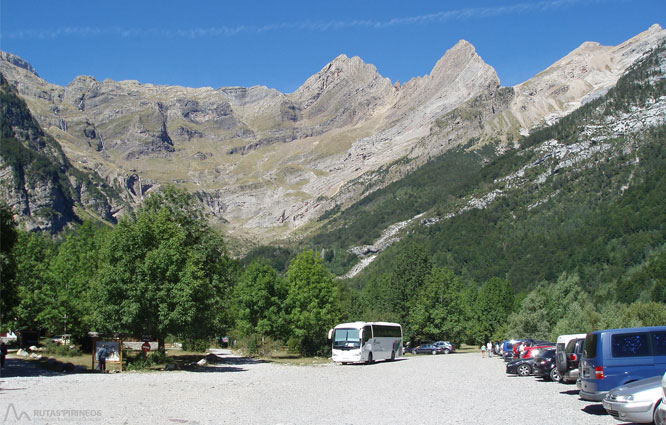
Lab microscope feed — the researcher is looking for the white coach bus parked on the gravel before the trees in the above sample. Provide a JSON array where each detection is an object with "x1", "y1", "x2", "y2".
[{"x1": 328, "y1": 322, "x2": 403, "y2": 364}]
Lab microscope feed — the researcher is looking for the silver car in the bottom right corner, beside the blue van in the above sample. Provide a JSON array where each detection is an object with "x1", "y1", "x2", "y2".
[{"x1": 601, "y1": 375, "x2": 662, "y2": 424}]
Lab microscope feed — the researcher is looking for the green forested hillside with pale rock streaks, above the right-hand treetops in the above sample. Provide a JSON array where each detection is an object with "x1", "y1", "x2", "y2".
[{"x1": 312, "y1": 42, "x2": 666, "y2": 290}]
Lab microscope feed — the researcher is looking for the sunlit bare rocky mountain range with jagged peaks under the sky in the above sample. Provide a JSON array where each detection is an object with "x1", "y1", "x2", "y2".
[{"x1": 0, "y1": 25, "x2": 666, "y2": 242}]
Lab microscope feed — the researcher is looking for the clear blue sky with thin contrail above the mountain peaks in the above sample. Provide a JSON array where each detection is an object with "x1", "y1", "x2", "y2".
[{"x1": 0, "y1": 0, "x2": 666, "y2": 93}]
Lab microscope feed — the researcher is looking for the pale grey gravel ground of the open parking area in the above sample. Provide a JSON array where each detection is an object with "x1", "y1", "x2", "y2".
[{"x1": 0, "y1": 353, "x2": 618, "y2": 425}]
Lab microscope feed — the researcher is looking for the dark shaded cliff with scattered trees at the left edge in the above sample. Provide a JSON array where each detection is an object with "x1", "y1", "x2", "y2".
[{"x1": 0, "y1": 74, "x2": 118, "y2": 233}]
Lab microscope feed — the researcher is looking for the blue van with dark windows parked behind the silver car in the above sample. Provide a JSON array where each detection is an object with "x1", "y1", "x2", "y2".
[{"x1": 579, "y1": 326, "x2": 666, "y2": 401}]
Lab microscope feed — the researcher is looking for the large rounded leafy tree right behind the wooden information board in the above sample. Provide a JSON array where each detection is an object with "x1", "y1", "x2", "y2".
[{"x1": 93, "y1": 188, "x2": 228, "y2": 348}]
